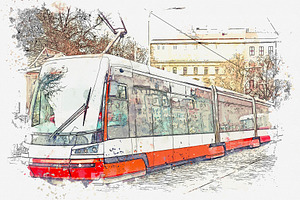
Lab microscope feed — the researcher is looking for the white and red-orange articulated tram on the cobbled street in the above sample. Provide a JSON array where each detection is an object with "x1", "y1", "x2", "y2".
[{"x1": 26, "y1": 54, "x2": 274, "y2": 182}]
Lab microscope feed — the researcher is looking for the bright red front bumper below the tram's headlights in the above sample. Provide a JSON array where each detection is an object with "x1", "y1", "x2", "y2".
[{"x1": 28, "y1": 158, "x2": 103, "y2": 180}]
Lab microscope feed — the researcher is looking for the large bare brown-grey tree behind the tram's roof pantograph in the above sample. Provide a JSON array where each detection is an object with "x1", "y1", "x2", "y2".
[{"x1": 10, "y1": 5, "x2": 147, "y2": 63}]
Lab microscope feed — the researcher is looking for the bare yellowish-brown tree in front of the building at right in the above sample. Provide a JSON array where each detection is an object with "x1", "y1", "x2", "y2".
[{"x1": 210, "y1": 54, "x2": 291, "y2": 107}]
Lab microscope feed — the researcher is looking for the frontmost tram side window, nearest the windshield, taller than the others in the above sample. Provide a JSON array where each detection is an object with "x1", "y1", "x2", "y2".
[{"x1": 107, "y1": 82, "x2": 129, "y2": 139}]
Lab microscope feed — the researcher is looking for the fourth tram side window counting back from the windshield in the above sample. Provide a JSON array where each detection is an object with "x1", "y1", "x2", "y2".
[{"x1": 171, "y1": 95, "x2": 188, "y2": 135}]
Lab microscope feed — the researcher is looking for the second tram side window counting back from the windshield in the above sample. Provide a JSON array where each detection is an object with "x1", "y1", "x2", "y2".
[{"x1": 134, "y1": 87, "x2": 152, "y2": 137}]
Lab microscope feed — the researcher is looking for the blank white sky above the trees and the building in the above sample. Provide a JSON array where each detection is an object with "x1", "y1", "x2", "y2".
[{"x1": 2, "y1": 0, "x2": 300, "y2": 45}]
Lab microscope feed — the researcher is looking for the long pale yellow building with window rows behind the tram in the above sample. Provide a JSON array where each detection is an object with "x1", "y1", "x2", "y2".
[{"x1": 150, "y1": 28, "x2": 278, "y2": 86}]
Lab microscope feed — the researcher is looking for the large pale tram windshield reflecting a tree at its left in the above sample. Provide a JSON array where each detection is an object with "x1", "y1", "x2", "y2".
[{"x1": 30, "y1": 58, "x2": 102, "y2": 143}]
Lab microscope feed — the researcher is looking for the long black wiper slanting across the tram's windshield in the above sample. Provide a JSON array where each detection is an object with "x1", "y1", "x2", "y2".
[{"x1": 49, "y1": 88, "x2": 92, "y2": 139}]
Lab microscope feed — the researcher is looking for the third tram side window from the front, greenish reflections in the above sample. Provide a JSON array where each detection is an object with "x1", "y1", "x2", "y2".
[{"x1": 151, "y1": 90, "x2": 171, "y2": 135}]
